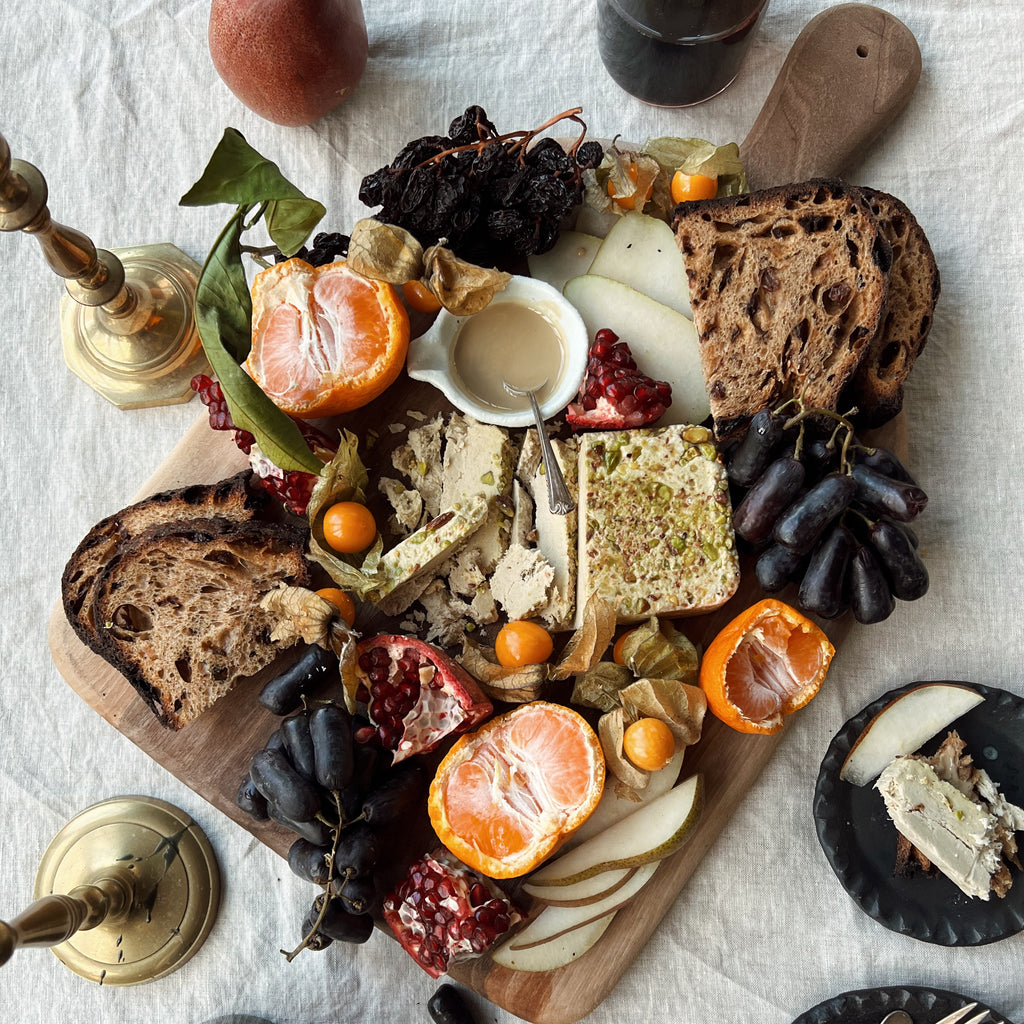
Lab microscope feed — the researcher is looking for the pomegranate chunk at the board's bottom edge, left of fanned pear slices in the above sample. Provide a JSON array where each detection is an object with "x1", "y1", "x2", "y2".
[{"x1": 384, "y1": 851, "x2": 522, "y2": 978}]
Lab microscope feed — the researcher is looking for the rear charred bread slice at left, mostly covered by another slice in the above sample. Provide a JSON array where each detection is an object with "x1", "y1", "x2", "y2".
[{"x1": 60, "y1": 469, "x2": 267, "y2": 646}]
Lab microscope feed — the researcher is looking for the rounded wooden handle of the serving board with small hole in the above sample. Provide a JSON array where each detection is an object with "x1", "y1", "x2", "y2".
[{"x1": 739, "y1": 3, "x2": 921, "y2": 189}]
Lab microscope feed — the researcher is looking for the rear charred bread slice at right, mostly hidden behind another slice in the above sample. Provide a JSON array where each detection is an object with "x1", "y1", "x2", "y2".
[{"x1": 842, "y1": 188, "x2": 940, "y2": 427}]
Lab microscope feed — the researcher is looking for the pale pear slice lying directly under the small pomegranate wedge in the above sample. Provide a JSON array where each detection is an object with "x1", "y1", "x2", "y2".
[{"x1": 562, "y1": 273, "x2": 711, "y2": 426}]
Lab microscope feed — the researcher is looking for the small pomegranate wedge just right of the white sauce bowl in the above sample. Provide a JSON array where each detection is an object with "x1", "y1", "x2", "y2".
[{"x1": 565, "y1": 328, "x2": 672, "y2": 430}]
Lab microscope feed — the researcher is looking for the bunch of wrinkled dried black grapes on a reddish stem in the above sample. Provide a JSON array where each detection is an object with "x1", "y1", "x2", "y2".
[{"x1": 359, "y1": 105, "x2": 604, "y2": 266}]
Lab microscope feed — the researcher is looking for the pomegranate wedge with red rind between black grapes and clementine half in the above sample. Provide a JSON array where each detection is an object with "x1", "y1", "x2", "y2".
[{"x1": 356, "y1": 634, "x2": 494, "y2": 764}]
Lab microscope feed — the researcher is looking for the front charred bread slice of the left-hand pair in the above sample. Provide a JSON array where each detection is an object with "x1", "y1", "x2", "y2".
[{"x1": 91, "y1": 519, "x2": 309, "y2": 729}]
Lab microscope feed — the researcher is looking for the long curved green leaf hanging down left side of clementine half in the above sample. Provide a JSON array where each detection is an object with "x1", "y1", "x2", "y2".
[{"x1": 196, "y1": 206, "x2": 323, "y2": 475}]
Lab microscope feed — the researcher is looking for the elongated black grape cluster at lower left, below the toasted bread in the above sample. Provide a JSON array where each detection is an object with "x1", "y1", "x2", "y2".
[{"x1": 237, "y1": 644, "x2": 426, "y2": 959}]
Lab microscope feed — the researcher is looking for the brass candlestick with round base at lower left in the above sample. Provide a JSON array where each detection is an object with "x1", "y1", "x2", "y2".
[{"x1": 0, "y1": 797, "x2": 220, "y2": 985}]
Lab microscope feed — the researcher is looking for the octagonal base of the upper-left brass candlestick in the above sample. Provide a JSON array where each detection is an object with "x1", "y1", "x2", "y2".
[{"x1": 60, "y1": 243, "x2": 209, "y2": 409}]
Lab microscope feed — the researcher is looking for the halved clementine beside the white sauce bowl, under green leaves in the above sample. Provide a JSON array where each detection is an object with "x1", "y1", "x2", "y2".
[{"x1": 245, "y1": 259, "x2": 409, "y2": 418}]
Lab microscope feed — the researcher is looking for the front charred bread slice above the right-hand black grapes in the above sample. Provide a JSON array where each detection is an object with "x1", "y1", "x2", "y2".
[{"x1": 673, "y1": 179, "x2": 892, "y2": 437}]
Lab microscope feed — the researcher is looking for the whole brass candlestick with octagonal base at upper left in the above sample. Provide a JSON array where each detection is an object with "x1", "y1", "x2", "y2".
[{"x1": 0, "y1": 135, "x2": 209, "y2": 409}]
